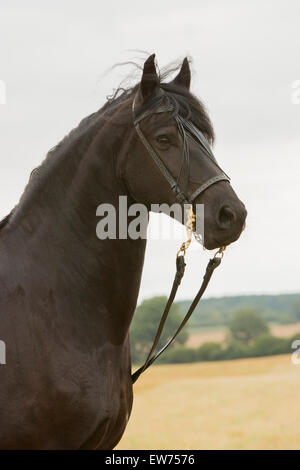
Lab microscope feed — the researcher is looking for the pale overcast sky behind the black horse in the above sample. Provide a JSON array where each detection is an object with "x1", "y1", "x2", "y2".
[{"x1": 0, "y1": 0, "x2": 300, "y2": 299}]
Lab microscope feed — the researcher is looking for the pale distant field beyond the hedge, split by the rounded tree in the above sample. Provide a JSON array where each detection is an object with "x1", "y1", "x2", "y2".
[{"x1": 187, "y1": 323, "x2": 300, "y2": 348}]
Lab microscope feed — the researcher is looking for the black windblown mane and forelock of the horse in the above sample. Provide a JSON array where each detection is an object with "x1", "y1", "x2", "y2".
[{"x1": 0, "y1": 56, "x2": 215, "y2": 230}]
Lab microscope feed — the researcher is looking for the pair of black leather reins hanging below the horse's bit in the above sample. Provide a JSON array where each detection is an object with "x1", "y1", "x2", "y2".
[{"x1": 131, "y1": 256, "x2": 221, "y2": 383}]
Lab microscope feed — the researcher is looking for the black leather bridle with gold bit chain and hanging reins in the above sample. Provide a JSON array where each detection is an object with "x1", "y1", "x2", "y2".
[{"x1": 131, "y1": 93, "x2": 230, "y2": 383}]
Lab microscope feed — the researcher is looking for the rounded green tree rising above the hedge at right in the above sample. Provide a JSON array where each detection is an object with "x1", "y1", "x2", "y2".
[{"x1": 229, "y1": 309, "x2": 269, "y2": 344}]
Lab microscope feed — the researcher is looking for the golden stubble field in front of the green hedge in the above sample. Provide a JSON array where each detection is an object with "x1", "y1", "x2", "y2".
[{"x1": 117, "y1": 355, "x2": 300, "y2": 449}]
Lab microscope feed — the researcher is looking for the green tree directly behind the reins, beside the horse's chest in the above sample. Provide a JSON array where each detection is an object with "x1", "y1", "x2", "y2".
[{"x1": 130, "y1": 297, "x2": 188, "y2": 363}]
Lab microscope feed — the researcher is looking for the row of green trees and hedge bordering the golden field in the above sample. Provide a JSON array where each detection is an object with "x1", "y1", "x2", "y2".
[{"x1": 131, "y1": 297, "x2": 300, "y2": 364}]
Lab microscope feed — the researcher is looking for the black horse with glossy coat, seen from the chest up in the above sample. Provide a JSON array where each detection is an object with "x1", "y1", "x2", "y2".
[{"x1": 0, "y1": 55, "x2": 246, "y2": 449}]
